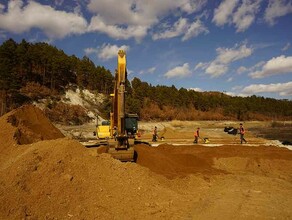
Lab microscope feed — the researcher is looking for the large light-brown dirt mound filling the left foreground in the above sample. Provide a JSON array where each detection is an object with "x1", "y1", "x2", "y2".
[{"x1": 0, "y1": 138, "x2": 204, "y2": 219}]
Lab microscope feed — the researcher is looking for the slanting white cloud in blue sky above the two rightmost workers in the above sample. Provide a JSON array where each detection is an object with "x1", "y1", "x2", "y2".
[{"x1": 195, "y1": 44, "x2": 253, "y2": 78}]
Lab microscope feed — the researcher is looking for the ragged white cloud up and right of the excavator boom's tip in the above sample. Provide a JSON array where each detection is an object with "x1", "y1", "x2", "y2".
[{"x1": 152, "y1": 18, "x2": 209, "y2": 41}]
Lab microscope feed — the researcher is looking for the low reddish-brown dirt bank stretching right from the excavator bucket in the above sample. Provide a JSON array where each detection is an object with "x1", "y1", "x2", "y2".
[{"x1": 135, "y1": 144, "x2": 292, "y2": 182}]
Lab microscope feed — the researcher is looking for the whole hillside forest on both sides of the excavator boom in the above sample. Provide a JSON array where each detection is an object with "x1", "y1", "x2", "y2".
[{"x1": 0, "y1": 39, "x2": 292, "y2": 123}]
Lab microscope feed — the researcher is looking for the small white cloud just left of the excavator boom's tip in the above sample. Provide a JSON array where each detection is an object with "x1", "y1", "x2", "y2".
[{"x1": 84, "y1": 44, "x2": 130, "y2": 60}]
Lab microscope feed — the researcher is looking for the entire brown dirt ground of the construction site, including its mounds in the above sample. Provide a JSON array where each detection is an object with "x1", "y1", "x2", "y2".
[{"x1": 0, "y1": 106, "x2": 292, "y2": 220}]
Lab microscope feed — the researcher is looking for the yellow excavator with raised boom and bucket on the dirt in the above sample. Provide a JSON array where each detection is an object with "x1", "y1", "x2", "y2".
[{"x1": 97, "y1": 50, "x2": 143, "y2": 161}]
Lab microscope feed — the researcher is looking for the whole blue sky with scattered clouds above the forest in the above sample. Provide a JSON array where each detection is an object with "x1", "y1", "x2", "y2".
[{"x1": 0, "y1": 0, "x2": 292, "y2": 100}]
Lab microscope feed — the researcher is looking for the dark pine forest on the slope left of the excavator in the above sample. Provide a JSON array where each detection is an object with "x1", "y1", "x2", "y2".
[{"x1": 0, "y1": 39, "x2": 114, "y2": 118}]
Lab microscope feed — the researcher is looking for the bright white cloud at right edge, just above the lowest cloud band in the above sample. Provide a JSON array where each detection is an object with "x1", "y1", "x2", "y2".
[{"x1": 249, "y1": 55, "x2": 292, "y2": 78}]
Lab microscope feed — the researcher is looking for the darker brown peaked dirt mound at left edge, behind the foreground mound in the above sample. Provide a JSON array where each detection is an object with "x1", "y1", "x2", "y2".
[{"x1": 0, "y1": 105, "x2": 64, "y2": 145}]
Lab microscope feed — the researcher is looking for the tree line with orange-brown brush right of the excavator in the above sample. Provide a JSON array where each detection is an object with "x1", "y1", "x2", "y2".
[{"x1": 127, "y1": 78, "x2": 292, "y2": 120}]
